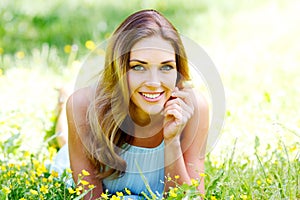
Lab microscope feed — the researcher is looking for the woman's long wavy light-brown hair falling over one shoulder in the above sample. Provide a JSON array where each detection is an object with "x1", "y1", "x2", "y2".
[{"x1": 85, "y1": 10, "x2": 190, "y2": 180}]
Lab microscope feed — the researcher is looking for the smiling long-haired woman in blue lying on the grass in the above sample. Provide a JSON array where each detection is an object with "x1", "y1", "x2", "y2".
[{"x1": 58, "y1": 10, "x2": 209, "y2": 198}]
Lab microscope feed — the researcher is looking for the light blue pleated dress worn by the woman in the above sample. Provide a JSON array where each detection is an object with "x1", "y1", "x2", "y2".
[{"x1": 51, "y1": 142, "x2": 165, "y2": 199}]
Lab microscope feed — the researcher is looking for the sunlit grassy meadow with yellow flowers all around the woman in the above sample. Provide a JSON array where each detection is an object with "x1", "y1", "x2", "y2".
[{"x1": 0, "y1": 0, "x2": 300, "y2": 200}]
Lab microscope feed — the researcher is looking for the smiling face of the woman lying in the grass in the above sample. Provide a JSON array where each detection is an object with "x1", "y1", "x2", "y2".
[{"x1": 127, "y1": 36, "x2": 177, "y2": 115}]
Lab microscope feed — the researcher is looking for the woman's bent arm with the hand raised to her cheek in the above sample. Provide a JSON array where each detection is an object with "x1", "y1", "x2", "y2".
[{"x1": 164, "y1": 89, "x2": 209, "y2": 193}]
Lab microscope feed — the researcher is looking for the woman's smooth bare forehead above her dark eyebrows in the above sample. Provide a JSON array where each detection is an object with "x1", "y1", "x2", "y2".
[{"x1": 130, "y1": 36, "x2": 175, "y2": 59}]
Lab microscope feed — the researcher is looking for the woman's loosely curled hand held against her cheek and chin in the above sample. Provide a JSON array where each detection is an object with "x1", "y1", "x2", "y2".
[{"x1": 163, "y1": 87, "x2": 194, "y2": 142}]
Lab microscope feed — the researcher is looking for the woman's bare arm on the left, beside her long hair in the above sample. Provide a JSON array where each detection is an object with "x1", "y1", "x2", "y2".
[{"x1": 67, "y1": 88, "x2": 103, "y2": 199}]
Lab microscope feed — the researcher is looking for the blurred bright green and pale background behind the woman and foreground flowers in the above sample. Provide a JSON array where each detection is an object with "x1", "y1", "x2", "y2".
[{"x1": 0, "y1": 0, "x2": 300, "y2": 155}]
